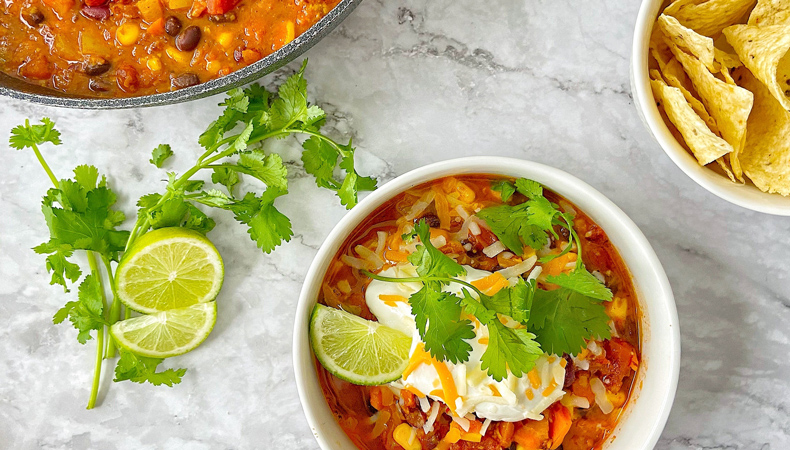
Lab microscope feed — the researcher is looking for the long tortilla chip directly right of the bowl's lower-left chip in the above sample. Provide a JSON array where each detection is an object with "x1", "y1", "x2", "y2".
[{"x1": 673, "y1": 49, "x2": 754, "y2": 179}]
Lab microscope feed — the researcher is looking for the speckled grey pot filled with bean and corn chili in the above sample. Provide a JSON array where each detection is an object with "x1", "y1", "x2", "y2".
[{"x1": 0, "y1": 0, "x2": 361, "y2": 109}]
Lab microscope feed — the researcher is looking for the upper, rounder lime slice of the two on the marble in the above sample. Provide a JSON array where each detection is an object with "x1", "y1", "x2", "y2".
[{"x1": 116, "y1": 227, "x2": 225, "y2": 314}]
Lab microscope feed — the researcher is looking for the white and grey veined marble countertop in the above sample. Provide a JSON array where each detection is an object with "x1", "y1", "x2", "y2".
[{"x1": 0, "y1": 0, "x2": 790, "y2": 450}]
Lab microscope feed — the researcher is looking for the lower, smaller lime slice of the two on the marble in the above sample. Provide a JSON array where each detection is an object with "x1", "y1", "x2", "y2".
[{"x1": 110, "y1": 302, "x2": 217, "y2": 358}]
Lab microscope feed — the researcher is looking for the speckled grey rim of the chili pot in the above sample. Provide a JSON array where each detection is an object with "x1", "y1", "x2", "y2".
[{"x1": 0, "y1": 0, "x2": 362, "y2": 109}]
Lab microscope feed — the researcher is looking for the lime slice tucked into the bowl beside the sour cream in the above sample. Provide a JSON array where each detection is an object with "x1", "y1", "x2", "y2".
[{"x1": 310, "y1": 305, "x2": 411, "y2": 385}]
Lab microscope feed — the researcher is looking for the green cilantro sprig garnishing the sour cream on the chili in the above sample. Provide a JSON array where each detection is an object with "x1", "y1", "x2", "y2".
[{"x1": 365, "y1": 178, "x2": 612, "y2": 381}]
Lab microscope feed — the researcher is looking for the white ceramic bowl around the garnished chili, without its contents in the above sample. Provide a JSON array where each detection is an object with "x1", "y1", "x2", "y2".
[{"x1": 293, "y1": 157, "x2": 680, "y2": 450}]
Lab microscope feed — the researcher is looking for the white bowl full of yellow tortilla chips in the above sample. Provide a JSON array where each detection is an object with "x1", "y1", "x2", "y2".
[{"x1": 631, "y1": 0, "x2": 790, "y2": 216}]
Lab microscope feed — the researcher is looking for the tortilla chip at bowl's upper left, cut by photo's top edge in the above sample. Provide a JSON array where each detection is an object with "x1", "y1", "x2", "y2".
[{"x1": 664, "y1": 0, "x2": 756, "y2": 37}]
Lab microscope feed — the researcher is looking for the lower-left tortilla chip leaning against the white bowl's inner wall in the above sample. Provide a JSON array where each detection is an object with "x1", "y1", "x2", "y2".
[{"x1": 650, "y1": 80, "x2": 733, "y2": 166}]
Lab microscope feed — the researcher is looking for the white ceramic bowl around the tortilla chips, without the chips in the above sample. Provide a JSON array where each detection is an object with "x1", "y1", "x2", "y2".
[{"x1": 631, "y1": 0, "x2": 790, "y2": 216}]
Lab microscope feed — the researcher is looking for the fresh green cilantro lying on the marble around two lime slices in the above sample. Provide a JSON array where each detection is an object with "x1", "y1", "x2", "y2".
[{"x1": 9, "y1": 61, "x2": 376, "y2": 409}]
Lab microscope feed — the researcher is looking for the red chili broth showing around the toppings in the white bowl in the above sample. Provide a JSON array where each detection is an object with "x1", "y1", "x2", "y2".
[{"x1": 316, "y1": 175, "x2": 641, "y2": 450}]
